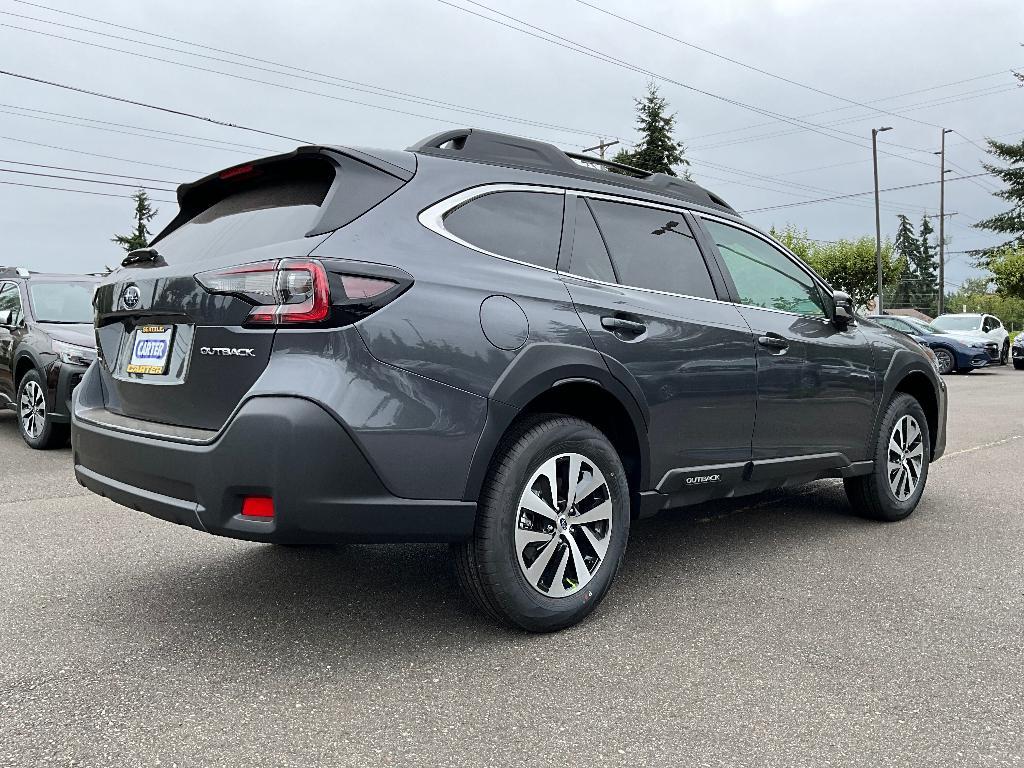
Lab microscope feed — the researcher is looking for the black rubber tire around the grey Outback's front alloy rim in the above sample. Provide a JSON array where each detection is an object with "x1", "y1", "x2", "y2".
[{"x1": 844, "y1": 393, "x2": 932, "y2": 522}]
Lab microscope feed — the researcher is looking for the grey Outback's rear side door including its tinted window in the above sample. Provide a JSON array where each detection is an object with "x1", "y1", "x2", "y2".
[{"x1": 560, "y1": 195, "x2": 755, "y2": 495}]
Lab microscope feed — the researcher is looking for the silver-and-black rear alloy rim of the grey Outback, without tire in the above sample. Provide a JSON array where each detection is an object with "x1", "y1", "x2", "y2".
[{"x1": 514, "y1": 453, "x2": 612, "y2": 597}]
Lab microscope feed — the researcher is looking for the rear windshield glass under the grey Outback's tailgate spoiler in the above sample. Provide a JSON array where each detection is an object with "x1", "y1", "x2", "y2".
[{"x1": 154, "y1": 174, "x2": 333, "y2": 263}]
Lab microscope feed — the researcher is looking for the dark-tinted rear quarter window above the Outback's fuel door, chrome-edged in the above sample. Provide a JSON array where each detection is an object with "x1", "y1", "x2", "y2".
[{"x1": 444, "y1": 191, "x2": 565, "y2": 269}]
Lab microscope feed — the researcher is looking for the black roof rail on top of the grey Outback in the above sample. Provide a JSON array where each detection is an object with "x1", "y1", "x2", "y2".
[{"x1": 409, "y1": 128, "x2": 736, "y2": 213}]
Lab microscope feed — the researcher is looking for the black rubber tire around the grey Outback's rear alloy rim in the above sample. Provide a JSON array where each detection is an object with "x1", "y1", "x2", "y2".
[{"x1": 453, "y1": 415, "x2": 630, "y2": 632}]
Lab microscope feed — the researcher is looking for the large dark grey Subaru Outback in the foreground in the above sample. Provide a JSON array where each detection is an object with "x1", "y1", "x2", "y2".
[{"x1": 73, "y1": 130, "x2": 946, "y2": 631}]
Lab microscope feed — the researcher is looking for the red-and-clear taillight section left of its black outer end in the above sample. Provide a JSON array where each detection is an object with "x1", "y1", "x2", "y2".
[{"x1": 196, "y1": 259, "x2": 331, "y2": 326}]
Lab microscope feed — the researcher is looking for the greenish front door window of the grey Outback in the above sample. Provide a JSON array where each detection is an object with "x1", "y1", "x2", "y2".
[{"x1": 705, "y1": 220, "x2": 827, "y2": 316}]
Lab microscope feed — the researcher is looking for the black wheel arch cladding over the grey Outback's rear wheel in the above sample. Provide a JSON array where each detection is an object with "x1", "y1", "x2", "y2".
[{"x1": 464, "y1": 344, "x2": 650, "y2": 500}]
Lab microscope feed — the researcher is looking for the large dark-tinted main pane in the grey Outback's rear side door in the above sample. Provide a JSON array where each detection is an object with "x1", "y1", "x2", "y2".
[{"x1": 589, "y1": 200, "x2": 716, "y2": 299}]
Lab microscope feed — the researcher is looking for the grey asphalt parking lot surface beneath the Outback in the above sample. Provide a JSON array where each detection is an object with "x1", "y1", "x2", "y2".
[{"x1": 0, "y1": 369, "x2": 1024, "y2": 766}]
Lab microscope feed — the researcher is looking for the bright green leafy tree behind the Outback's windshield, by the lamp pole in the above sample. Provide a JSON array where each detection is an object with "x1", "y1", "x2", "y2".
[{"x1": 771, "y1": 226, "x2": 906, "y2": 306}]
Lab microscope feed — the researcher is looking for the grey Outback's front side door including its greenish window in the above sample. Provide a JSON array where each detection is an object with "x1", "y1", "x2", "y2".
[{"x1": 701, "y1": 217, "x2": 877, "y2": 471}]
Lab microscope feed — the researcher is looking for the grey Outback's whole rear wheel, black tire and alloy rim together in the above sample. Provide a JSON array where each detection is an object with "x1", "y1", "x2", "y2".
[{"x1": 455, "y1": 416, "x2": 630, "y2": 632}]
